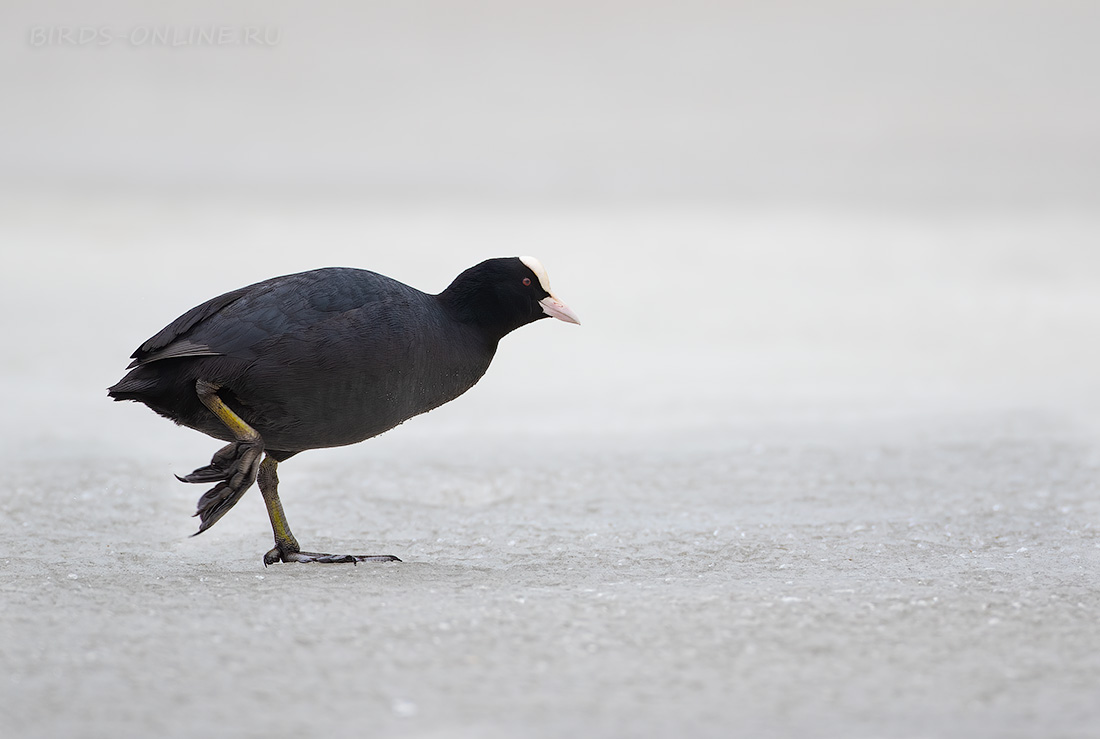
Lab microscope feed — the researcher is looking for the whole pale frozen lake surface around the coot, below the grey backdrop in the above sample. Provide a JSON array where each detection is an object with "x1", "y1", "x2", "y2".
[{"x1": 0, "y1": 191, "x2": 1100, "y2": 738}]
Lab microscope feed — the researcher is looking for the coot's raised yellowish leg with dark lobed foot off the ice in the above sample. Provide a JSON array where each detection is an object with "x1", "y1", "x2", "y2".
[{"x1": 179, "y1": 379, "x2": 264, "y2": 536}]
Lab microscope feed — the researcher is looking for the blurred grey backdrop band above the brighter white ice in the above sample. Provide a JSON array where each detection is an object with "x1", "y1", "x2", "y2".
[{"x1": 0, "y1": 0, "x2": 1100, "y2": 209}]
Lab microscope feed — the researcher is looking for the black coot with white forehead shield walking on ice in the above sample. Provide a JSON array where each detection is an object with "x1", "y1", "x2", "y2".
[{"x1": 108, "y1": 256, "x2": 581, "y2": 566}]
